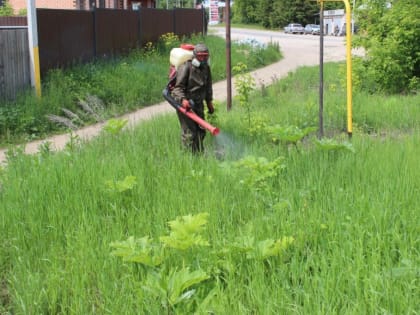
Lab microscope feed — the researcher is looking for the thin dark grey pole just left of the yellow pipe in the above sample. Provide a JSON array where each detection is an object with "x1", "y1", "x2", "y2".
[{"x1": 318, "y1": 0, "x2": 324, "y2": 138}]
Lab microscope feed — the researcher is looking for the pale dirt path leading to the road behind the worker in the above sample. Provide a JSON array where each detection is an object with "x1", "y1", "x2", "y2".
[{"x1": 0, "y1": 27, "x2": 360, "y2": 164}]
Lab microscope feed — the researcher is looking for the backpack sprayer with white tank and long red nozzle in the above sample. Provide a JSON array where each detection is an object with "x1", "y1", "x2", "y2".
[{"x1": 162, "y1": 44, "x2": 220, "y2": 136}]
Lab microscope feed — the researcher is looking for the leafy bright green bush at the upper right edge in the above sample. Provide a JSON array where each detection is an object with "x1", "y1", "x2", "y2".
[{"x1": 355, "y1": 0, "x2": 420, "y2": 93}]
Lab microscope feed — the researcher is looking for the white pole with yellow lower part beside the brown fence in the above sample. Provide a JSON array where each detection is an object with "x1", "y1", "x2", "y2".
[{"x1": 27, "y1": 0, "x2": 41, "y2": 97}]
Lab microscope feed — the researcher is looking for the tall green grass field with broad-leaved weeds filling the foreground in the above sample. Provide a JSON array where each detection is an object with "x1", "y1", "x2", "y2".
[{"x1": 0, "y1": 64, "x2": 420, "y2": 314}]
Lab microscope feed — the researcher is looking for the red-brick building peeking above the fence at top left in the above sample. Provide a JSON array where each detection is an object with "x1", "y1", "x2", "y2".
[{"x1": 5, "y1": 0, "x2": 156, "y2": 14}]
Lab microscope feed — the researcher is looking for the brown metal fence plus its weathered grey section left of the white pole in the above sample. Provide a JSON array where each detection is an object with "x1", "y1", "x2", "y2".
[{"x1": 0, "y1": 8, "x2": 205, "y2": 99}]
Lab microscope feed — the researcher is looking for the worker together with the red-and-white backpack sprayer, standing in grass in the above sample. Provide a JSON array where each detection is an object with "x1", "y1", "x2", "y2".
[{"x1": 163, "y1": 44, "x2": 219, "y2": 153}]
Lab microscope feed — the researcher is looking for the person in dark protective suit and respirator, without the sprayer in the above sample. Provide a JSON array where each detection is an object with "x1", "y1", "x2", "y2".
[{"x1": 172, "y1": 44, "x2": 214, "y2": 153}]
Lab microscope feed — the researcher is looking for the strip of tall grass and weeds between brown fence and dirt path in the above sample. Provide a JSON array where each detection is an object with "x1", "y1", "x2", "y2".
[{"x1": 0, "y1": 34, "x2": 281, "y2": 147}]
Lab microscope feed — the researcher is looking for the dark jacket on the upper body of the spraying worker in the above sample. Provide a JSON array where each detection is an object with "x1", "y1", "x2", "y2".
[{"x1": 172, "y1": 61, "x2": 213, "y2": 107}]
